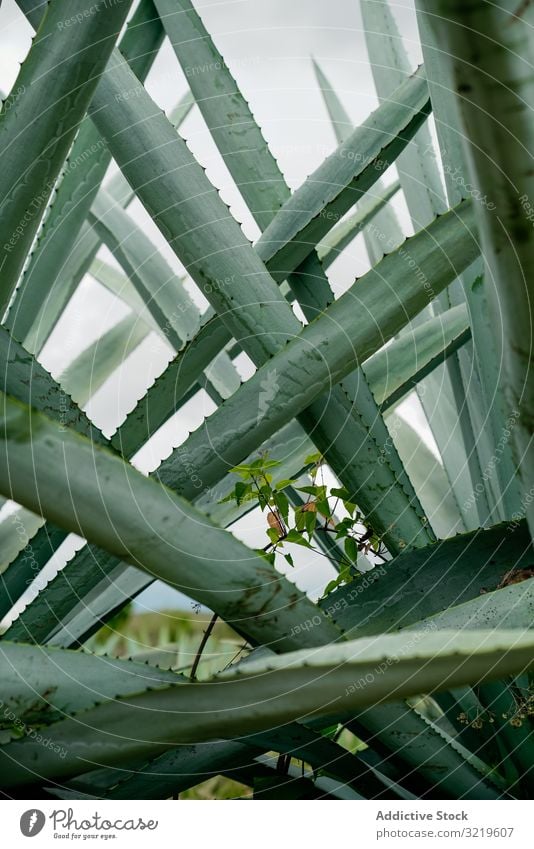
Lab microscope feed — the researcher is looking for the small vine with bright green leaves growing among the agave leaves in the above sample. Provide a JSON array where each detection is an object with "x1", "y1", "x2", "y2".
[{"x1": 220, "y1": 454, "x2": 383, "y2": 595}]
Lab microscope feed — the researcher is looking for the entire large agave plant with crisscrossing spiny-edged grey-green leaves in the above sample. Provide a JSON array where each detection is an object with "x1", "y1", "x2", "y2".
[{"x1": 0, "y1": 0, "x2": 534, "y2": 799}]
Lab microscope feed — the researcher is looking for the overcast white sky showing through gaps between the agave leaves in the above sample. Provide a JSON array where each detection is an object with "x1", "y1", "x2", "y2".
[{"x1": 0, "y1": 0, "x2": 444, "y2": 624}]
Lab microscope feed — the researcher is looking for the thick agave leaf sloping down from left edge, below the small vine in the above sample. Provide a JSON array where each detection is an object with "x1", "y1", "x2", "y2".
[{"x1": 0, "y1": 395, "x2": 338, "y2": 648}]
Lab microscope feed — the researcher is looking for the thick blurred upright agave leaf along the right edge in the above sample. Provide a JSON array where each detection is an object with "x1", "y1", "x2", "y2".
[{"x1": 420, "y1": 3, "x2": 534, "y2": 533}]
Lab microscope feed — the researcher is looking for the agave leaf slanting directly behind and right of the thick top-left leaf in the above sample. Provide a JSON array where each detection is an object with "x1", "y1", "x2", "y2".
[{"x1": 8, "y1": 0, "x2": 163, "y2": 344}]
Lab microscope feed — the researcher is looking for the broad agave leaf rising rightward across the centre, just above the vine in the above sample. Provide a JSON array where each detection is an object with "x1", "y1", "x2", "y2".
[{"x1": 160, "y1": 207, "x2": 476, "y2": 516}]
